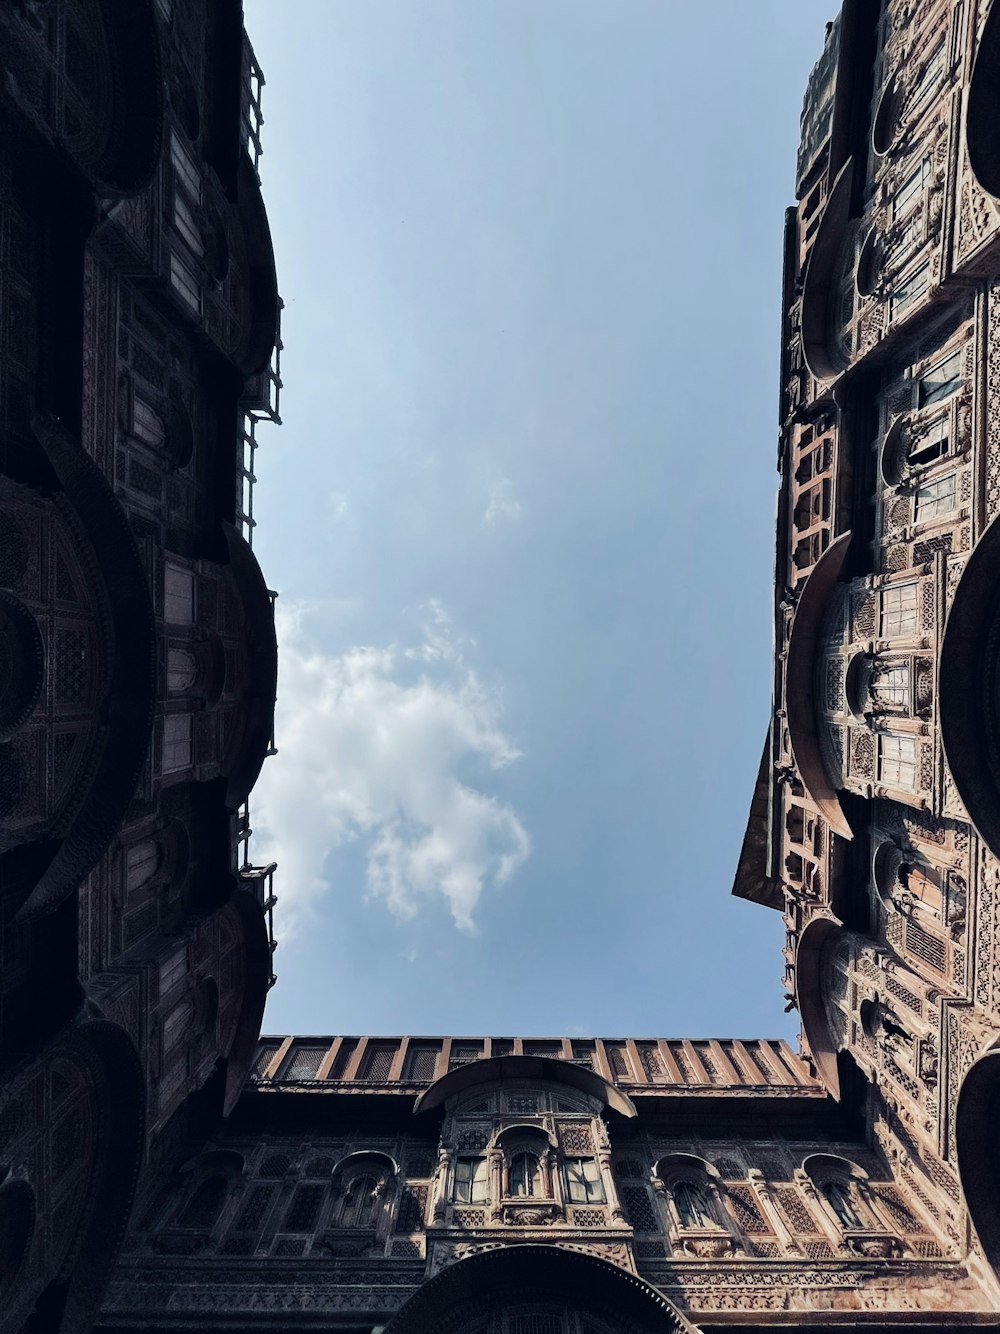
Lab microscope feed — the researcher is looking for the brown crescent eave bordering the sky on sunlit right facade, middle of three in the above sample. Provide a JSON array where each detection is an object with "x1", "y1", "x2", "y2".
[{"x1": 785, "y1": 532, "x2": 855, "y2": 839}]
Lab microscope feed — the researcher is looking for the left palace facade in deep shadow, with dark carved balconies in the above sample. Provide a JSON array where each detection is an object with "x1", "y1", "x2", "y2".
[{"x1": 0, "y1": 0, "x2": 280, "y2": 1334}]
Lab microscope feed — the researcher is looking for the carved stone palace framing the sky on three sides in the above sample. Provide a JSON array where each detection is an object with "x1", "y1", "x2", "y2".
[{"x1": 7, "y1": 0, "x2": 1000, "y2": 1334}]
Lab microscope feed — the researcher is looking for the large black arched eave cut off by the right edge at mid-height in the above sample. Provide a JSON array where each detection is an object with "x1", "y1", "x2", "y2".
[{"x1": 937, "y1": 509, "x2": 1000, "y2": 856}]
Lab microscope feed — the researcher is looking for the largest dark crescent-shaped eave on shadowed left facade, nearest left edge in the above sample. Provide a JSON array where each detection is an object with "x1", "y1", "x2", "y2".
[{"x1": 20, "y1": 415, "x2": 156, "y2": 919}]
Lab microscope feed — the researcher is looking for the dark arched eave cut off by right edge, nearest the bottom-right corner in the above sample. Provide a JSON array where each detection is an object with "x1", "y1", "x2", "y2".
[{"x1": 955, "y1": 1049, "x2": 1000, "y2": 1277}]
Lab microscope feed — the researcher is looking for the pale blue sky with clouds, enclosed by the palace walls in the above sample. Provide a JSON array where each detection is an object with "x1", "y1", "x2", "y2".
[{"x1": 245, "y1": 0, "x2": 836, "y2": 1039}]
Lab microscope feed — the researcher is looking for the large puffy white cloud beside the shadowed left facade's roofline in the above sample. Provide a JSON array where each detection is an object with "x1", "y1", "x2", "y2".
[{"x1": 251, "y1": 602, "x2": 529, "y2": 936}]
